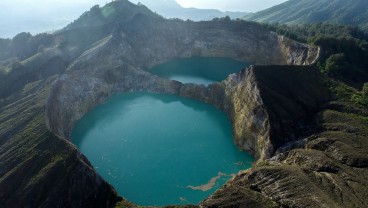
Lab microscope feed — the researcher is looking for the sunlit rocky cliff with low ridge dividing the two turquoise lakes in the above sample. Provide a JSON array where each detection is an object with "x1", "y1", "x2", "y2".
[{"x1": 179, "y1": 69, "x2": 274, "y2": 160}]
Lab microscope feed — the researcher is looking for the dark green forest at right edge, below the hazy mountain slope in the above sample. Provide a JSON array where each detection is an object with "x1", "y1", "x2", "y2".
[{"x1": 262, "y1": 23, "x2": 368, "y2": 89}]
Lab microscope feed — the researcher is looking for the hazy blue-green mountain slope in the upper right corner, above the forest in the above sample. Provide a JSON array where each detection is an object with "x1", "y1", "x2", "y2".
[{"x1": 244, "y1": 0, "x2": 368, "y2": 27}]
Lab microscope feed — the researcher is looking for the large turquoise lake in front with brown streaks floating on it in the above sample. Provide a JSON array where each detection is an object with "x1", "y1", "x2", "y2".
[{"x1": 72, "y1": 59, "x2": 253, "y2": 206}]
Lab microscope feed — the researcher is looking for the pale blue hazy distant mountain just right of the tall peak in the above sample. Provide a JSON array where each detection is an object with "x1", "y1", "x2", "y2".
[{"x1": 134, "y1": 0, "x2": 249, "y2": 21}]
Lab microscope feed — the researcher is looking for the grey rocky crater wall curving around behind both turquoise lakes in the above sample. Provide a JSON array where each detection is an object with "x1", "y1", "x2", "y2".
[{"x1": 46, "y1": 19, "x2": 318, "y2": 151}]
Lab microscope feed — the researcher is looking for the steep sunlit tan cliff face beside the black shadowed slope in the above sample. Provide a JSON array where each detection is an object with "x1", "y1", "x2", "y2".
[{"x1": 217, "y1": 67, "x2": 274, "y2": 160}]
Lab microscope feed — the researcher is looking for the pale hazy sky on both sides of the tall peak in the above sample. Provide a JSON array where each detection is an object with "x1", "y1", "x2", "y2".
[{"x1": 0, "y1": 0, "x2": 286, "y2": 38}]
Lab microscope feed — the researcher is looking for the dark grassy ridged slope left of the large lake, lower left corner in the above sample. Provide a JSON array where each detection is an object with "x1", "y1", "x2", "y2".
[{"x1": 0, "y1": 78, "x2": 117, "y2": 207}]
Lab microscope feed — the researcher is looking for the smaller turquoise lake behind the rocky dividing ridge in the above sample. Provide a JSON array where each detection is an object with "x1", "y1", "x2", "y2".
[{"x1": 148, "y1": 57, "x2": 249, "y2": 85}]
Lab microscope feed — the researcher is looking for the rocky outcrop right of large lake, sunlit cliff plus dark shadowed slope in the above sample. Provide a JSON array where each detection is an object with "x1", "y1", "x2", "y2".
[{"x1": 179, "y1": 66, "x2": 329, "y2": 161}]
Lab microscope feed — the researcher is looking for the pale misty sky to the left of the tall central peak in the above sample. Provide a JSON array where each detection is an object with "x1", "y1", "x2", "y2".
[{"x1": 0, "y1": 0, "x2": 99, "y2": 38}]
